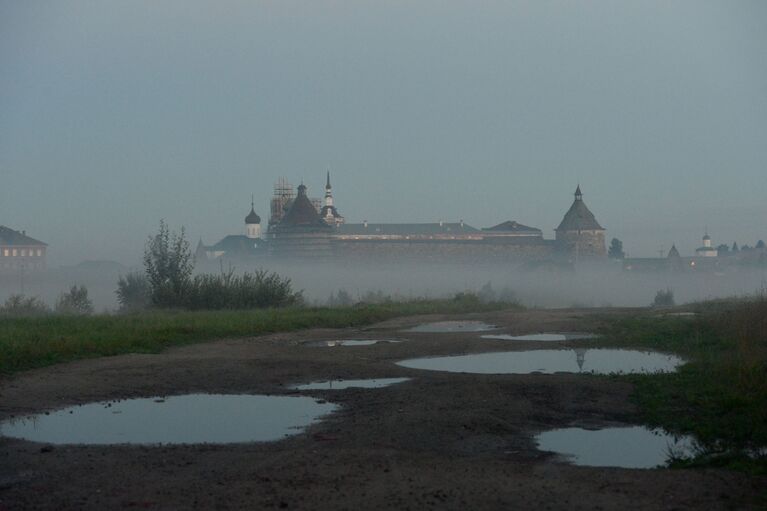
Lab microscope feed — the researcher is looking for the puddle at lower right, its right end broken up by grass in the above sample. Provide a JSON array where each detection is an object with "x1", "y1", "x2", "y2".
[{"x1": 535, "y1": 426, "x2": 694, "y2": 468}]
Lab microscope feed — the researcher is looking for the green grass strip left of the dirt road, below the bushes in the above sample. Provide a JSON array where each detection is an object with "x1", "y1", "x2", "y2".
[{"x1": 0, "y1": 296, "x2": 518, "y2": 374}]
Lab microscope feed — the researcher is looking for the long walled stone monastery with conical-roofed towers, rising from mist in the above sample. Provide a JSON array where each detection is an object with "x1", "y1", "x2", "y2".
[{"x1": 197, "y1": 174, "x2": 607, "y2": 263}]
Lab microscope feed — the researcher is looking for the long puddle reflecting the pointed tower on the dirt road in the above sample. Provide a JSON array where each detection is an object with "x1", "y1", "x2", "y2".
[{"x1": 397, "y1": 348, "x2": 684, "y2": 374}]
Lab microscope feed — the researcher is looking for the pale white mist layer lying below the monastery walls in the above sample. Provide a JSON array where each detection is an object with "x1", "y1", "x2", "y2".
[{"x1": 7, "y1": 262, "x2": 767, "y2": 312}]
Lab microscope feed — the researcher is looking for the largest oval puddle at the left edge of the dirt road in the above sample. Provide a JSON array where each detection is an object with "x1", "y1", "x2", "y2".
[{"x1": 0, "y1": 394, "x2": 337, "y2": 445}]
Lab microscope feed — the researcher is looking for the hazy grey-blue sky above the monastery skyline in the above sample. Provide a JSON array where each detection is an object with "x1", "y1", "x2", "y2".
[{"x1": 0, "y1": 0, "x2": 767, "y2": 265}]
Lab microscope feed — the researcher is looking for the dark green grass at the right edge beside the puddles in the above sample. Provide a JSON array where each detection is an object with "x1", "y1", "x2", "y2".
[{"x1": 591, "y1": 298, "x2": 767, "y2": 474}]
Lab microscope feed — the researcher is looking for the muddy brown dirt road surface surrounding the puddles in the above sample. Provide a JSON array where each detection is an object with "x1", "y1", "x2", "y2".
[{"x1": 0, "y1": 310, "x2": 766, "y2": 510}]
